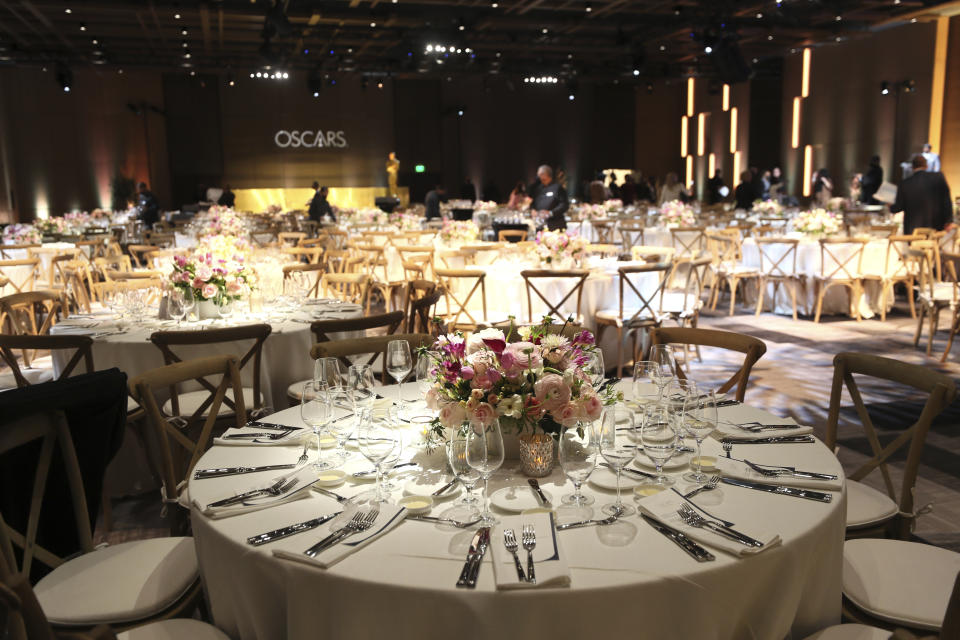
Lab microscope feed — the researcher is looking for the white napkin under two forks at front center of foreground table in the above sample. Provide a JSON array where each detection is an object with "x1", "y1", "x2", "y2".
[{"x1": 489, "y1": 513, "x2": 570, "y2": 589}]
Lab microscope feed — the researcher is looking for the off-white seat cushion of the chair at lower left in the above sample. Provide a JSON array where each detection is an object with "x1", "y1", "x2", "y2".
[{"x1": 34, "y1": 538, "x2": 200, "y2": 625}]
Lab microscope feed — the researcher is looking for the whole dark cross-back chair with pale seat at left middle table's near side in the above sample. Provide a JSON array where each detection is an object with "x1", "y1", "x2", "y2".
[{"x1": 148, "y1": 324, "x2": 272, "y2": 420}]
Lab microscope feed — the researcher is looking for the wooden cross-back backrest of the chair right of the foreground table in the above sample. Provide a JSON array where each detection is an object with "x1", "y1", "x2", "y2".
[{"x1": 826, "y1": 352, "x2": 957, "y2": 539}]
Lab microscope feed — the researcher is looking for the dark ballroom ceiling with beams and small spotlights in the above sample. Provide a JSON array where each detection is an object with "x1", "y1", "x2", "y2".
[{"x1": 0, "y1": 0, "x2": 960, "y2": 82}]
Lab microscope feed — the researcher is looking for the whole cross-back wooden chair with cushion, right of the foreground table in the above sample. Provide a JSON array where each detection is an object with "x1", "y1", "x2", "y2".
[{"x1": 825, "y1": 353, "x2": 957, "y2": 540}]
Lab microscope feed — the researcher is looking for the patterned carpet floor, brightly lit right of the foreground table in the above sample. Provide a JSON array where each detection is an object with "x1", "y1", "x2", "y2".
[{"x1": 97, "y1": 300, "x2": 960, "y2": 551}]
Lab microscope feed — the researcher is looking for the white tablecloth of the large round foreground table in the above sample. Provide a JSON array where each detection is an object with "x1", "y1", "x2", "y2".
[{"x1": 189, "y1": 385, "x2": 846, "y2": 640}]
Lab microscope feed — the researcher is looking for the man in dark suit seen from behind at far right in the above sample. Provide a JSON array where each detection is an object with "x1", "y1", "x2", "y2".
[{"x1": 890, "y1": 154, "x2": 953, "y2": 234}]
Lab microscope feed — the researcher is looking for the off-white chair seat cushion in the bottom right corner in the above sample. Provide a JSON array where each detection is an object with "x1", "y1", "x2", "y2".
[{"x1": 843, "y1": 538, "x2": 960, "y2": 631}]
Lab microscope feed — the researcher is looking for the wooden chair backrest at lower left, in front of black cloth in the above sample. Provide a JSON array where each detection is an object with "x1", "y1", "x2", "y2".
[{"x1": 0, "y1": 410, "x2": 93, "y2": 577}]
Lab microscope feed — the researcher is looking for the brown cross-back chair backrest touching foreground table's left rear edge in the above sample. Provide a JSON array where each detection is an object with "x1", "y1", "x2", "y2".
[{"x1": 130, "y1": 356, "x2": 246, "y2": 510}]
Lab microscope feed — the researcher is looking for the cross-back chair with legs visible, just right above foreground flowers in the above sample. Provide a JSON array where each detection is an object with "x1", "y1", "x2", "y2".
[{"x1": 594, "y1": 262, "x2": 671, "y2": 378}]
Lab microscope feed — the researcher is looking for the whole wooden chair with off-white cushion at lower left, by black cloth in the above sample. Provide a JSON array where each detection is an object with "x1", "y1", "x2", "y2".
[{"x1": 0, "y1": 410, "x2": 203, "y2": 640}]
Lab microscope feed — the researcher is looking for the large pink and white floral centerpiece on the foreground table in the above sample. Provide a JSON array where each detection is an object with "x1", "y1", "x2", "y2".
[{"x1": 426, "y1": 317, "x2": 622, "y2": 475}]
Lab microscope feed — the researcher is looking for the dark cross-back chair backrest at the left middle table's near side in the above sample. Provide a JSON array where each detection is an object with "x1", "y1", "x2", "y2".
[{"x1": 150, "y1": 324, "x2": 272, "y2": 419}]
